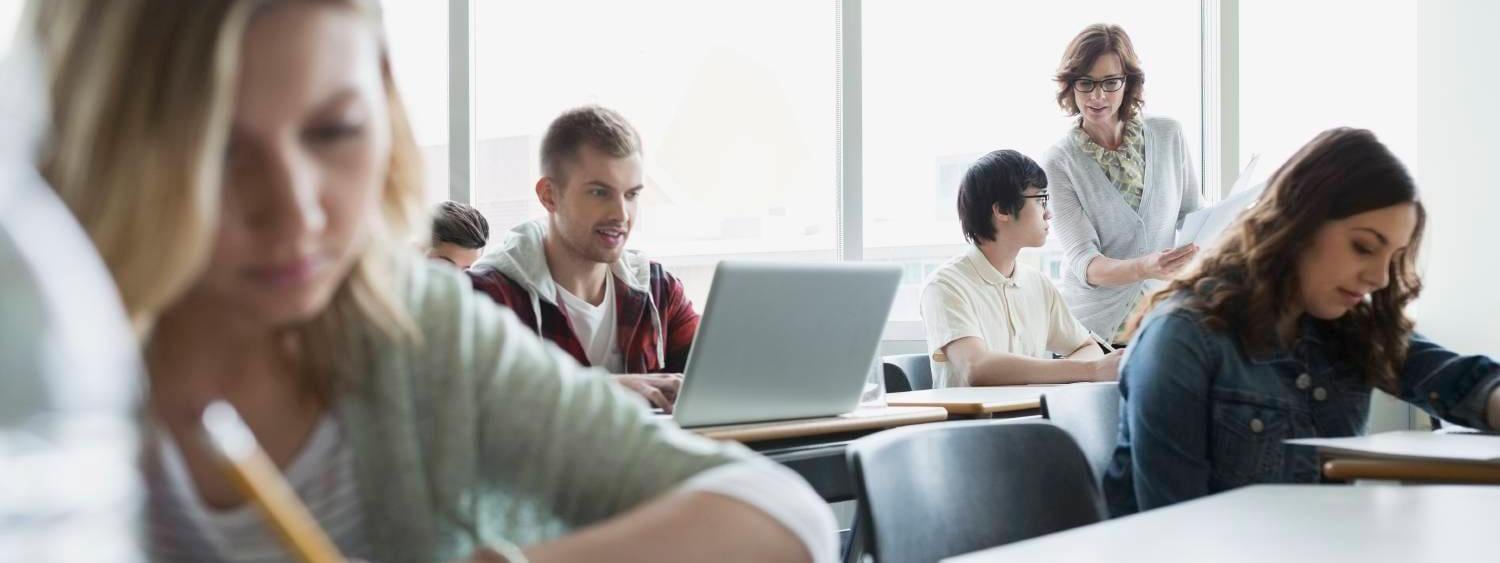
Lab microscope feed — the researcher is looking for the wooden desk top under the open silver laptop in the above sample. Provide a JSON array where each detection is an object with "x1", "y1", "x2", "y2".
[{"x1": 689, "y1": 407, "x2": 948, "y2": 441}]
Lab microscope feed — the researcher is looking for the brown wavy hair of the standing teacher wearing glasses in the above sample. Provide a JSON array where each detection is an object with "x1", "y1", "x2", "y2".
[{"x1": 1053, "y1": 24, "x2": 1146, "y2": 122}]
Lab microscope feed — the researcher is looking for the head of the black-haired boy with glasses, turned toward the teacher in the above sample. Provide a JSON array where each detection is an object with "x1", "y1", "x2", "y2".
[{"x1": 959, "y1": 150, "x2": 1052, "y2": 248}]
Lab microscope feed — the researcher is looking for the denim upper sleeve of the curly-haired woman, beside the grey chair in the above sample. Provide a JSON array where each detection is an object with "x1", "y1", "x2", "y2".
[{"x1": 1121, "y1": 314, "x2": 1217, "y2": 510}]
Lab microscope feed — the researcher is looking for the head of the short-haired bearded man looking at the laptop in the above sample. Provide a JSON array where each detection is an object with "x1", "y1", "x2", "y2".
[{"x1": 537, "y1": 105, "x2": 645, "y2": 263}]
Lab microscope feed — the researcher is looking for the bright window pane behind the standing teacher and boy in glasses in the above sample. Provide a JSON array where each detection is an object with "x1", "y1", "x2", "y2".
[{"x1": 863, "y1": 0, "x2": 1202, "y2": 321}]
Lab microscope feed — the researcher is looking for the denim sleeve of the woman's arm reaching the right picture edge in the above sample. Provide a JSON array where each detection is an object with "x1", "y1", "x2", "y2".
[{"x1": 1401, "y1": 335, "x2": 1500, "y2": 431}]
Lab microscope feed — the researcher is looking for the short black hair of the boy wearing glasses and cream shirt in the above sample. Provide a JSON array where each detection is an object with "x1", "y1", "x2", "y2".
[{"x1": 959, "y1": 149, "x2": 1047, "y2": 245}]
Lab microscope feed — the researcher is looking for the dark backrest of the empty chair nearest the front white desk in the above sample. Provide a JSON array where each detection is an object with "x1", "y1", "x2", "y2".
[{"x1": 848, "y1": 420, "x2": 1106, "y2": 563}]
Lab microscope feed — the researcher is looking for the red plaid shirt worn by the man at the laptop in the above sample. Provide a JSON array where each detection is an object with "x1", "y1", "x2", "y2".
[{"x1": 468, "y1": 261, "x2": 698, "y2": 374}]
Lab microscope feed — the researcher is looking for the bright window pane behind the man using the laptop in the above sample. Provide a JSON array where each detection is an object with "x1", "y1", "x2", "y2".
[{"x1": 473, "y1": 0, "x2": 837, "y2": 306}]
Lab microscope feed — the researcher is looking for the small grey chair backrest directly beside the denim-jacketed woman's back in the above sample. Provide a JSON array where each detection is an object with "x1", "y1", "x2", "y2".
[{"x1": 1041, "y1": 381, "x2": 1121, "y2": 479}]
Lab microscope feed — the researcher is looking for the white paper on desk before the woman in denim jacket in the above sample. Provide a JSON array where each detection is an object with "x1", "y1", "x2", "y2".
[{"x1": 1287, "y1": 431, "x2": 1500, "y2": 464}]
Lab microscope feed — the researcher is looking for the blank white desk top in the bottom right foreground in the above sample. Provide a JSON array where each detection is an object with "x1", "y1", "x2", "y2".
[{"x1": 945, "y1": 485, "x2": 1500, "y2": 563}]
